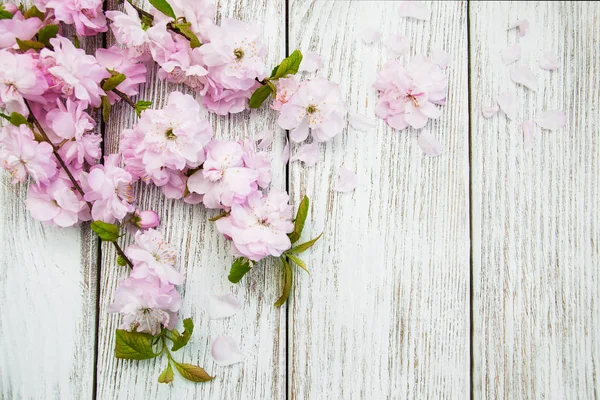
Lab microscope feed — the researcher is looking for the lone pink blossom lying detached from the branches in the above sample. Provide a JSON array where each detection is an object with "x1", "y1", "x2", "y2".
[{"x1": 373, "y1": 58, "x2": 448, "y2": 130}]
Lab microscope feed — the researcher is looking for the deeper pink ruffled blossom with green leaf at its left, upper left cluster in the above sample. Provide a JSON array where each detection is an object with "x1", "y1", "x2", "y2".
[{"x1": 96, "y1": 45, "x2": 146, "y2": 104}]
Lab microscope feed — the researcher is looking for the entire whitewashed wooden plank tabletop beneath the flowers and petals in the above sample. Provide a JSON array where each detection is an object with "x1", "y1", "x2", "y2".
[{"x1": 0, "y1": 0, "x2": 600, "y2": 400}]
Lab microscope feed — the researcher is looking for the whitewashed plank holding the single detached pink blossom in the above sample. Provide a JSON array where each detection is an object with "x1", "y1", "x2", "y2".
[{"x1": 288, "y1": 0, "x2": 470, "y2": 399}]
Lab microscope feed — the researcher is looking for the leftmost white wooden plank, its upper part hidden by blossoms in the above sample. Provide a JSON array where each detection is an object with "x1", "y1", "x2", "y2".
[{"x1": 0, "y1": 22, "x2": 102, "y2": 400}]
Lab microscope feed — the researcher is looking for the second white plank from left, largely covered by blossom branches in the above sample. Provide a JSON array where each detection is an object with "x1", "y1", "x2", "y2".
[{"x1": 97, "y1": 0, "x2": 286, "y2": 400}]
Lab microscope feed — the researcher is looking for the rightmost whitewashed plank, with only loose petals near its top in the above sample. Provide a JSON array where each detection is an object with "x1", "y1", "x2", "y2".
[{"x1": 470, "y1": 2, "x2": 600, "y2": 399}]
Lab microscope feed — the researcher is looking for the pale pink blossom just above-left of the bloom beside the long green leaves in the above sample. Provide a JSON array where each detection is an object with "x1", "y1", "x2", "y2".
[{"x1": 187, "y1": 140, "x2": 271, "y2": 209}]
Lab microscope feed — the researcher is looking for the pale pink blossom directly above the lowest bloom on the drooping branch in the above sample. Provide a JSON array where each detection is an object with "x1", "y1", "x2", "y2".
[{"x1": 125, "y1": 229, "x2": 183, "y2": 285}]
